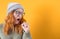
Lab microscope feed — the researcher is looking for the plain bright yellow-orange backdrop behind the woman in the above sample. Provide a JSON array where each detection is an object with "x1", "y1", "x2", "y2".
[{"x1": 0, "y1": 0, "x2": 60, "y2": 39}]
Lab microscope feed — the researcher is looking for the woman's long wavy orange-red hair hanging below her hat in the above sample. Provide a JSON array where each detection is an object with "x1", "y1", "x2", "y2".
[{"x1": 3, "y1": 11, "x2": 25, "y2": 35}]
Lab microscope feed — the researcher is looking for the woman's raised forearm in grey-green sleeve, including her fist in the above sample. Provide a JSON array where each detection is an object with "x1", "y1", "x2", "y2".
[{"x1": 22, "y1": 22, "x2": 32, "y2": 39}]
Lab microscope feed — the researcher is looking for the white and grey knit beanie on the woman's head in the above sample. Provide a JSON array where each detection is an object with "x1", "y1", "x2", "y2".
[{"x1": 7, "y1": 2, "x2": 24, "y2": 14}]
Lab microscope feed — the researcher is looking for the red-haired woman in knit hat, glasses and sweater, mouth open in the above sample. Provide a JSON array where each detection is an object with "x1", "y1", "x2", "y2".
[{"x1": 0, "y1": 2, "x2": 31, "y2": 39}]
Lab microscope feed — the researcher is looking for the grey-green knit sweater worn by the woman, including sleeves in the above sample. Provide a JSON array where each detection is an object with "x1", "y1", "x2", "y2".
[{"x1": 0, "y1": 24, "x2": 32, "y2": 39}]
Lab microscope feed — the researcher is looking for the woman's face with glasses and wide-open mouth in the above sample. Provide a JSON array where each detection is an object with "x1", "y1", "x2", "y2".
[{"x1": 13, "y1": 9, "x2": 24, "y2": 24}]
